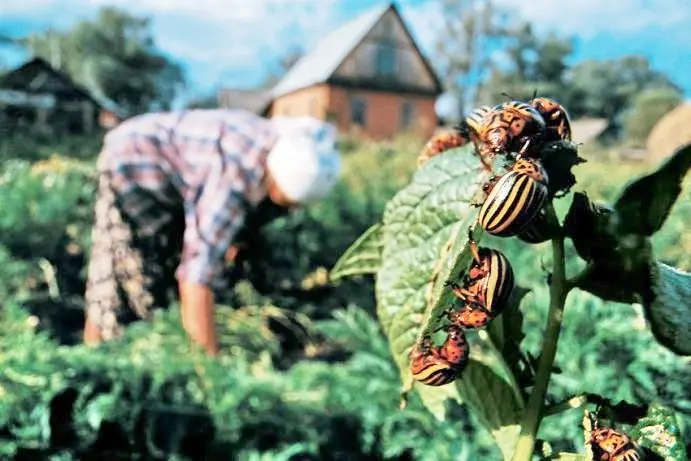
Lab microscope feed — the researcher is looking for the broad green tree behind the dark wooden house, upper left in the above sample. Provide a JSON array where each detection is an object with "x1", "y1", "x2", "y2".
[{"x1": 23, "y1": 7, "x2": 185, "y2": 114}]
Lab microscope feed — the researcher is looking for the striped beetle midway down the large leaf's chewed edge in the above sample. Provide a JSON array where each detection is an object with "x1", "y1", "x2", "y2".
[{"x1": 442, "y1": 234, "x2": 515, "y2": 328}]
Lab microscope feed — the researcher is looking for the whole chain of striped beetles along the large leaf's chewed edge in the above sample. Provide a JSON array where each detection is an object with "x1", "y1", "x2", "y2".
[{"x1": 411, "y1": 97, "x2": 571, "y2": 386}]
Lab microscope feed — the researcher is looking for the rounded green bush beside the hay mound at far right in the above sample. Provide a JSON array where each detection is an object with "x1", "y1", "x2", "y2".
[{"x1": 624, "y1": 88, "x2": 683, "y2": 147}]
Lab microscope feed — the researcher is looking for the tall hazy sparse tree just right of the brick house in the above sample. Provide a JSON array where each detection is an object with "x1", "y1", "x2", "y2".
[{"x1": 435, "y1": 0, "x2": 506, "y2": 118}]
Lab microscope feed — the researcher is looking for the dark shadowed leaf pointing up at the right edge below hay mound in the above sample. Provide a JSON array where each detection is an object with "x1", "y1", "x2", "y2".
[{"x1": 614, "y1": 144, "x2": 691, "y2": 236}]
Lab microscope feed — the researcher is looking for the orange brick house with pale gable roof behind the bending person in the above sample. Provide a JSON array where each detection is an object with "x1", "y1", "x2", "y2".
[{"x1": 219, "y1": 3, "x2": 443, "y2": 139}]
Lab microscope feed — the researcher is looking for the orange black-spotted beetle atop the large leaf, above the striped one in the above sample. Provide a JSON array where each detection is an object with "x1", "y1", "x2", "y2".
[{"x1": 483, "y1": 101, "x2": 547, "y2": 154}]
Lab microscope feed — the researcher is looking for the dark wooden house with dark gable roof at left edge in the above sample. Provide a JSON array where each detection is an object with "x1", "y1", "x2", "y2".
[{"x1": 0, "y1": 57, "x2": 123, "y2": 135}]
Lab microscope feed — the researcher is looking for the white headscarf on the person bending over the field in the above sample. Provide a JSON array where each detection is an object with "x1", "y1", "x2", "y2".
[{"x1": 267, "y1": 117, "x2": 341, "y2": 203}]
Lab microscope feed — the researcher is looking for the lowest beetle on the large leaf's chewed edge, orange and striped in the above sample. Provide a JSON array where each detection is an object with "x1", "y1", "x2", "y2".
[{"x1": 410, "y1": 325, "x2": 470, "y2": 386}]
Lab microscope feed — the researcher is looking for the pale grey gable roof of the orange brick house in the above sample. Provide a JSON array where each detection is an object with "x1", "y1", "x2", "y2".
[{"x1": 270, "y1": 2, "x2": 441, "y2": 98}]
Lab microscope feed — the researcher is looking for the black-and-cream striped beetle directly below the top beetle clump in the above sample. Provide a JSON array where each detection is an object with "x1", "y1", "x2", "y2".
[{"x1": 478, "y1": 156, "x2": 549, "y2": 237}]
